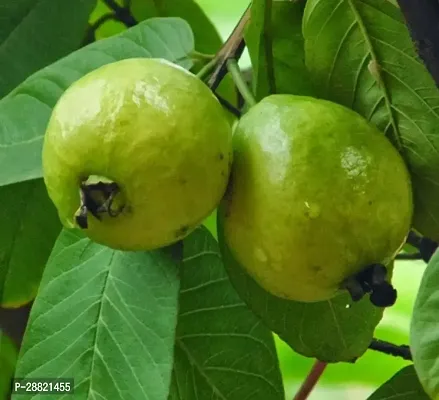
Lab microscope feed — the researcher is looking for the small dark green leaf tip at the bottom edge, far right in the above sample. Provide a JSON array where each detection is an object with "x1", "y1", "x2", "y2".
[{"x1": 367, "y1": 365, "x2": 430, "y2": 400}]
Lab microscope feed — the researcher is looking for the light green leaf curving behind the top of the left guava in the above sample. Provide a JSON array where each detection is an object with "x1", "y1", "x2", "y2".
[{"x1": 0, "y1": 18, "x2": 194, "y2": 186}]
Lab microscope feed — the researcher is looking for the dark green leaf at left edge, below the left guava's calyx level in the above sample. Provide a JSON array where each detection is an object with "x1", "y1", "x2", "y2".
[{"x1": 0, "y1": 179, "x2": 61, "y2": 308}]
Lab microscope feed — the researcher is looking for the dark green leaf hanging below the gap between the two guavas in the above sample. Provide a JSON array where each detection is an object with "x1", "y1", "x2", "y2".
[{"x1": 169, "y1": 227, "x2": 285, "y2": 400}]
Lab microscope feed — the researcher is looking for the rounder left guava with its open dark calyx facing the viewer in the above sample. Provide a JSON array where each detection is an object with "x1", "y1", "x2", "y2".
[{"x1": 42, "y1": 58, "x2": 232, "y2": 250}]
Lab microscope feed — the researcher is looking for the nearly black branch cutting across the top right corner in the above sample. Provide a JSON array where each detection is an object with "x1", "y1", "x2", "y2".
[{"x1": 397, "y1": 0, "x2": 439, "y2": 87}]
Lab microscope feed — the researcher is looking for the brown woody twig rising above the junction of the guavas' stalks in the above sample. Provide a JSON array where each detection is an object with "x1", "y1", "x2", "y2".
[{"x1": 207, "y1": 5, "x2": 251, "y2": 90}]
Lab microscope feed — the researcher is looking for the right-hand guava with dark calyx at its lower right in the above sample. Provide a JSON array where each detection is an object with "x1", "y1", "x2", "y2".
[{"x1": 219, "y1": 95, "x2": 413, "y2": 302}]
